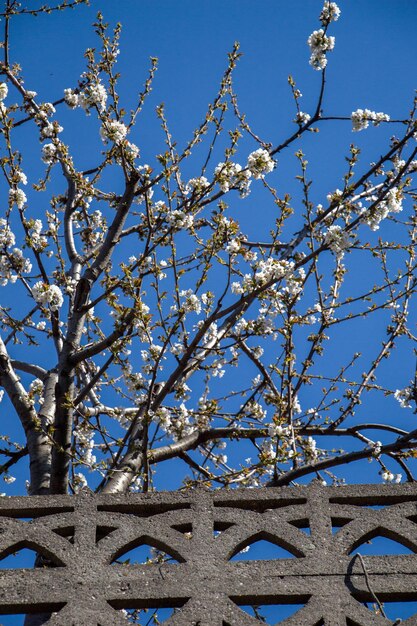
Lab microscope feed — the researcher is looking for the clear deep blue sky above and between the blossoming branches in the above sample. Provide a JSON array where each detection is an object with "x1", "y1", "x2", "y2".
[{"x1": 3, "y1": 0, "x2": 417, "y2": 490}]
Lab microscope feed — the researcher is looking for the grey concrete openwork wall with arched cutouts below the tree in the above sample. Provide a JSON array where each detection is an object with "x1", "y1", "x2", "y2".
[{"x1": 0, "y1": 481, "x2": 417, "y2": 626}]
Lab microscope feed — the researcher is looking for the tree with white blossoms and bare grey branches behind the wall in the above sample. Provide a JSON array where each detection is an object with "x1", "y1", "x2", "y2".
[{"x1": 0, "y1": 0, "x2": 417, "y2": 508}]
